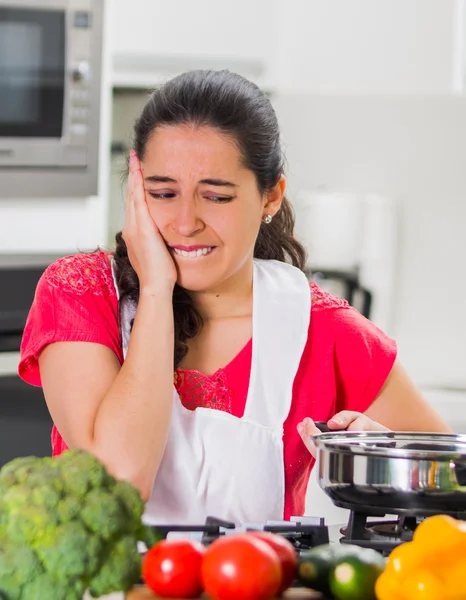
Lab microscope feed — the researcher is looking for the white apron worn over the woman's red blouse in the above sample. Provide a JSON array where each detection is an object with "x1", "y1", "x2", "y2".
[{"x1": 112, "y1": 260, "x2": 311, "y2": 524}]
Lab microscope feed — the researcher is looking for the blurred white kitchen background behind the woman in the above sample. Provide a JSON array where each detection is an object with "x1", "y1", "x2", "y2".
[{"x1": 0, "y1": 0, "x2": 466, "y2": 520}]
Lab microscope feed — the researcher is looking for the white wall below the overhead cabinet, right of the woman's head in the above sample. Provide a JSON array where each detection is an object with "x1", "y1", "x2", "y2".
[{"x1": 275, "y1": 94, "x2": 466, "y2": 387}]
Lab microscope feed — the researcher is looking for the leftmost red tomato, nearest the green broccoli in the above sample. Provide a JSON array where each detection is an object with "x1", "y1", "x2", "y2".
[{"x1": 142, "y1": 540, "x2": 205, "y2": 598}]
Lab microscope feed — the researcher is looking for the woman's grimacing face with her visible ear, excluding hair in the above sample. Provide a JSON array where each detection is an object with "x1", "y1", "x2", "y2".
[{"x1": 141, "y1": 125, "x2": 284, "y2": 291}]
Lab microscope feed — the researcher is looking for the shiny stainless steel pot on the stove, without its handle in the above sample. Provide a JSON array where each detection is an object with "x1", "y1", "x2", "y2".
[{"x1": 314, "y1": 431, "x2": 466, "y2": 515}]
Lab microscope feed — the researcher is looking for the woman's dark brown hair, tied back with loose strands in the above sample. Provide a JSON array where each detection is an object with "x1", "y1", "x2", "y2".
[{"x1": 114, "y1": 71, "x2": 306, "y2": 369}]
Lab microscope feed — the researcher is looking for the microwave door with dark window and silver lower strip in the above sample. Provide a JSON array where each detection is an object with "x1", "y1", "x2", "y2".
[{"x1": 0, "y1": 7, "x2": 73, "y2": 167}]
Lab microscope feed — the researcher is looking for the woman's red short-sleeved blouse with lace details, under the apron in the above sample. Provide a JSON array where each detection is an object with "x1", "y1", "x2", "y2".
[{"x1": 19, "y1": 252, "x2": 397, "y2": 519}]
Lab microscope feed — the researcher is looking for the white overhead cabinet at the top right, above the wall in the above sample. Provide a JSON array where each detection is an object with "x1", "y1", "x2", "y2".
[{"x1": 276, "y1": 0, "x2": 465, "y2": 93}]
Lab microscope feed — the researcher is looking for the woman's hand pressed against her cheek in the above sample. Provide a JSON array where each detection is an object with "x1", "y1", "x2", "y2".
[{"x1": 123, "y1": 150, "x2": 177, "y2": 294}]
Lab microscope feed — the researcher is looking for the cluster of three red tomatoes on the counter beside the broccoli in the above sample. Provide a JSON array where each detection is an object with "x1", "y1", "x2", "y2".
[{"x1": 142, "y1": 531, "x2": 297, "y2": 600}]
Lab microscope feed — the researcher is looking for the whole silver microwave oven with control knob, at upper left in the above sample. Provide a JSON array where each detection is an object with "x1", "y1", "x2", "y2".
[{"x1": 0, "y1": 0, "x2": 103, "y2": 197}]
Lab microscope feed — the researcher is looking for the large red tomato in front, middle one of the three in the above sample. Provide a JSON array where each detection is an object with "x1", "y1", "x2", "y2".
[{"x1": 202, "y1": 534, "x2": 282, "y2": 600}]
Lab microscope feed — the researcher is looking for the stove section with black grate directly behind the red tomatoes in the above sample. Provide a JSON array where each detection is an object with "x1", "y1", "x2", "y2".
[{"x1": 149, "y1": 517, "x2": 329, "y2": 553}]
